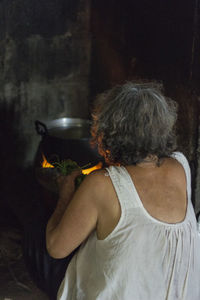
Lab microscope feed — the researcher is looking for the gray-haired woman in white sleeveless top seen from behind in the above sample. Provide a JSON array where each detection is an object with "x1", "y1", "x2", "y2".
[{"x1": 46, "y1": 83, "x2": 200, "y2": 300}]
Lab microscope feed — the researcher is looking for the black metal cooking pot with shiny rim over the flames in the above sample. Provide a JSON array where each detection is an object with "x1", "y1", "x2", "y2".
[{"x1": 35, "y1": 118, "x2": 103, "y2": 167}]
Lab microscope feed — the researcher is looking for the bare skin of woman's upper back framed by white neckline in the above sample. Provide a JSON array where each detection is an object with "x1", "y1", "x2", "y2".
[{"x1": 127, "y1": 158, "x2": 187, "y2": 223}]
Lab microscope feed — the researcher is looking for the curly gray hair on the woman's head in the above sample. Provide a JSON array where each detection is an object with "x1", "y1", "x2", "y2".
[{"x1": 91, "y1": 82, "x2": 177, "y2": 165}]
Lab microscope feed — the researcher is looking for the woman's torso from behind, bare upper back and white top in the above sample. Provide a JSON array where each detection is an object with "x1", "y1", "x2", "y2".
[{"x1": 58, "y1": 153, "x2": 200, "y2": 300}]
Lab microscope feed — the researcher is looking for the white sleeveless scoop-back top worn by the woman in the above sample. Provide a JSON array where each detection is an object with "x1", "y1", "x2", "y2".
[{"x1": 57, "y1": 152, "x2": 200, "y2": 300}]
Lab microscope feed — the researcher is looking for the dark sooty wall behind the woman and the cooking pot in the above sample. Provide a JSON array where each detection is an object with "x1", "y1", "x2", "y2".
[{"x1": 0, "y1": 0, "x2": 200, "y2": 216}]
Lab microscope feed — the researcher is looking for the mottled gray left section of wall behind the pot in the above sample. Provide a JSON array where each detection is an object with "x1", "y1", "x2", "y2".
[{"x1": 0, "y1": 0, "x2": 90, "y2": 166}]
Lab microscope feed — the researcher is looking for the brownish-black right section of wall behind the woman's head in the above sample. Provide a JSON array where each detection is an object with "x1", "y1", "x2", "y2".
[{"x1": 91, "y1": 0, "x2": 199, "y2": 160}]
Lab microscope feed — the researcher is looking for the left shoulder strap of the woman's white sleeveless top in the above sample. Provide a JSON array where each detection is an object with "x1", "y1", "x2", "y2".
[{"x1": 106, "y1": 166, "x2": 142, "y2": 210}]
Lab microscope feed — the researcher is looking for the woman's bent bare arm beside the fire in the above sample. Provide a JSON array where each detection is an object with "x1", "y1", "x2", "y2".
[{"x1": 46, "y1": 174, "x2": 99, "y2": 258}]
